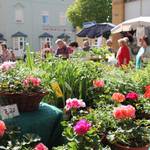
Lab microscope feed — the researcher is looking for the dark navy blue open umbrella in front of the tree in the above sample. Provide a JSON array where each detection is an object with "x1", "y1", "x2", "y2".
[{"x1": 77, "y1": 23, "x2": 115, "y2": 38}]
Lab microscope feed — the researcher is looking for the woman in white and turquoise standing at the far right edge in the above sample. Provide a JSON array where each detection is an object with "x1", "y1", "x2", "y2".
[{"x1": 136, "y1": 37, "x2": 148, "y2": 69}]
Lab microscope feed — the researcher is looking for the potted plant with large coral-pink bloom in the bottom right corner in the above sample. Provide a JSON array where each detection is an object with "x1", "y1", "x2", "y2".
[{"x1": 107, "y1": 105, "x2": 150, "y2": 150}]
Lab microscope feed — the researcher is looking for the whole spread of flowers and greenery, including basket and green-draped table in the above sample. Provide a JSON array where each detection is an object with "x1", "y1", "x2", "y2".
[{"x1": 0, "y1": 42, "x2": 150, "y2": 150}]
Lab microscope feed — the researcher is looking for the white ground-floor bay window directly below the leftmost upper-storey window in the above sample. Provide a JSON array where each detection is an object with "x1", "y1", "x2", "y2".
[{"x1": 13, "y1": 37, "x2": 26, "y2": 50}]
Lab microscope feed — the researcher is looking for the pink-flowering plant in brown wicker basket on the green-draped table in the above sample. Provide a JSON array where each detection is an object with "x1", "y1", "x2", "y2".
[{"x1": 0, "y1": 62, "x2": 47, "y2": 112}]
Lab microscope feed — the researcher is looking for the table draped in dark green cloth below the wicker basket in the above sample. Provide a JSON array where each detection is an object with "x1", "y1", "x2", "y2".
[{"x1": 5, "y1": 103, "x2": 63, "y2": 147}]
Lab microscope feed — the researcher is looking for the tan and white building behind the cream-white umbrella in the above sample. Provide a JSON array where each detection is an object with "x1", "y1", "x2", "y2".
[{"x1": 112, "y1": 0, "x2": 150, "y2": 48}]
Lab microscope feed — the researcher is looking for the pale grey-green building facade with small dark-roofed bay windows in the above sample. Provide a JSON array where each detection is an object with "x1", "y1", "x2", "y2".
[{"x1": 0, "y1": 0, "x2": 75, "y2": 55}]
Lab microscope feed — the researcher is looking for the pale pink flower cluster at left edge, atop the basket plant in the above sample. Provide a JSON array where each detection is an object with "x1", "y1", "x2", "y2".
[{"x1": 0, "y1": 61, "x2": 16, "y2": 71}]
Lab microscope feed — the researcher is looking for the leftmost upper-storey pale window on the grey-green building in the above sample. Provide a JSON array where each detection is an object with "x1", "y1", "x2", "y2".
[{"x1": 15, "y1": 4, "x2": 24, "y2": 23}]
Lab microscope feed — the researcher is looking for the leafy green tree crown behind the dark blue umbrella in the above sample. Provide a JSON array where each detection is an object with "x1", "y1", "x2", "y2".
[{"x1": 67, "y1": 0, "x2": 112, "y2": 27}]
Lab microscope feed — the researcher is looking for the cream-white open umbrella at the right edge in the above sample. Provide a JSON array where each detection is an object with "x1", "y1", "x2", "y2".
[{"x1": 111, "y1": 17, "x2": 150, "y2": 34}]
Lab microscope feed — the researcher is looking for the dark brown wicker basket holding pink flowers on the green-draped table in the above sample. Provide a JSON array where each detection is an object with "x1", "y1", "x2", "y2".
[{"x1": 0, "y1": 92, "x2": 48, "y2": 112}]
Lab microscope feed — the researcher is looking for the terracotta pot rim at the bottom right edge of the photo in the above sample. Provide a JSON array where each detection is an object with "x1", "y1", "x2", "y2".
[{"x1": 114, "y1": 144, "x2": 149, "y2": 150}]
